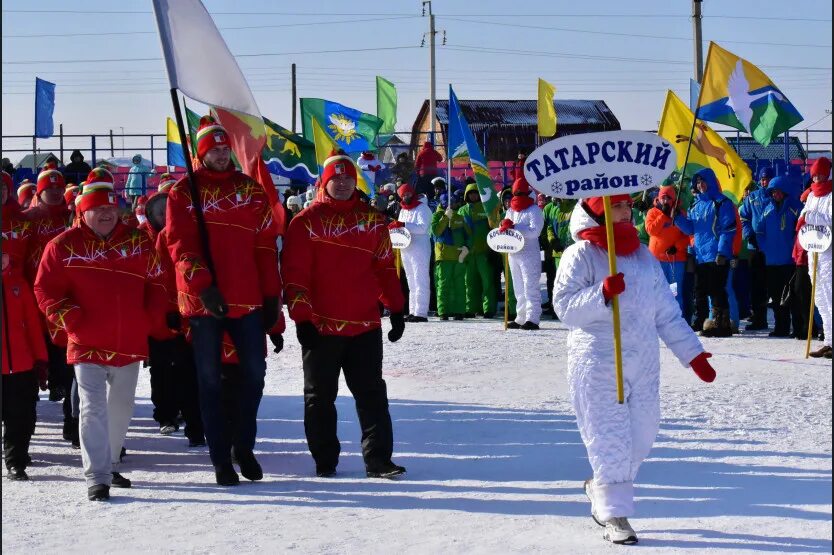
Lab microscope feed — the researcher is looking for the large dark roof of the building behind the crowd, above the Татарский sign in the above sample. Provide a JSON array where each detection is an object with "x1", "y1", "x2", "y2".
[{"x1": 418, "y1": 100, "x2": 620, "y2": 131}]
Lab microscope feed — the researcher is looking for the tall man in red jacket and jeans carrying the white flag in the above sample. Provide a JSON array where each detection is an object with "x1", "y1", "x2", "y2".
[{"x1": 166, "y1": 116, "x2": 283, "y2": 486}]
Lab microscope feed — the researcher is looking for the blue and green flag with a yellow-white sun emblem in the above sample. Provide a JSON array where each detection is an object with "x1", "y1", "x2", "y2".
[{"x1": 301, "y1": 98, "x2": 382, "y2": 154}]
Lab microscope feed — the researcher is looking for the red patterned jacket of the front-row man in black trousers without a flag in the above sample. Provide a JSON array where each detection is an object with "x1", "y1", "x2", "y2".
[{"x1": 281, "y1": 194, "x2": 403, "y2": 336}]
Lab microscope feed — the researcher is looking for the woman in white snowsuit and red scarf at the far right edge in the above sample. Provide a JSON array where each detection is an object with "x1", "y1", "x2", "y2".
[{"x1": 798, "y1": 158, "x2": 831, "y2": 358}]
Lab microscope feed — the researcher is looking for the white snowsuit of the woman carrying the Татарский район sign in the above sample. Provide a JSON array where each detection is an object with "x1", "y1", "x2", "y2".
[{"x1": 553, "y1": 207, "x2": 704, "y2": 520}]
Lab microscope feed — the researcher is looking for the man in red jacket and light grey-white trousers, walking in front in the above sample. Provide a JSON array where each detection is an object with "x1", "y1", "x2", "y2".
[{"x1": 35, "y1": 168, "x2": 168, "y2": 501}]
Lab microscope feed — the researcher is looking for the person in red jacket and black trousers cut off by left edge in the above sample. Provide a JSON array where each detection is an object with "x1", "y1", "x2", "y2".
[{"x1": 0, "y1": 172, "x2": 47, "y2": 480}]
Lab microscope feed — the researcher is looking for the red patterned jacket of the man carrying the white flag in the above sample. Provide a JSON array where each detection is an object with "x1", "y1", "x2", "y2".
[{"x1": 165, "y1": 168, "x2": 281, "y2": 318}]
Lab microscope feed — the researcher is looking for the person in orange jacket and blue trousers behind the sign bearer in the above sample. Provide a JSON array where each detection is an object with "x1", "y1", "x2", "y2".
[{"x1": 646, "y1": 185, "x2": 690, "y2": 311}]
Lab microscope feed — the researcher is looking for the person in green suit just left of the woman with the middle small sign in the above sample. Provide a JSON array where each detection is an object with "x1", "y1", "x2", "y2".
[{"x1": 458, "y1": 183, "x2": 496, "y2": 318}]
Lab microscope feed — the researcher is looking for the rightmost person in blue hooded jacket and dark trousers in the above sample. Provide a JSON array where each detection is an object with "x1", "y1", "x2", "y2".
[{"x1": 754, "y1": 176, "x2": 802, "y2": 337}]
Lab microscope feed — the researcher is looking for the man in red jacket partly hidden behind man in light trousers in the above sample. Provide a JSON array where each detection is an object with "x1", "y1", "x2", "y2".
[{"x1": 24, "y1": 163, "x2": 78, "y2": 444}]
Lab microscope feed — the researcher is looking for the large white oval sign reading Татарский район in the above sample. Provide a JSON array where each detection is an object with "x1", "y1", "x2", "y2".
[{"x1": 524, "y1": 131, "x2": 677, "y2": 198}]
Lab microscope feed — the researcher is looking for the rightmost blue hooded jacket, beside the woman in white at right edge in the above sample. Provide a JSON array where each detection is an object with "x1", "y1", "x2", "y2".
[{"x1": 755, "y1": 176, "x2": 802, "y2": 266}]
